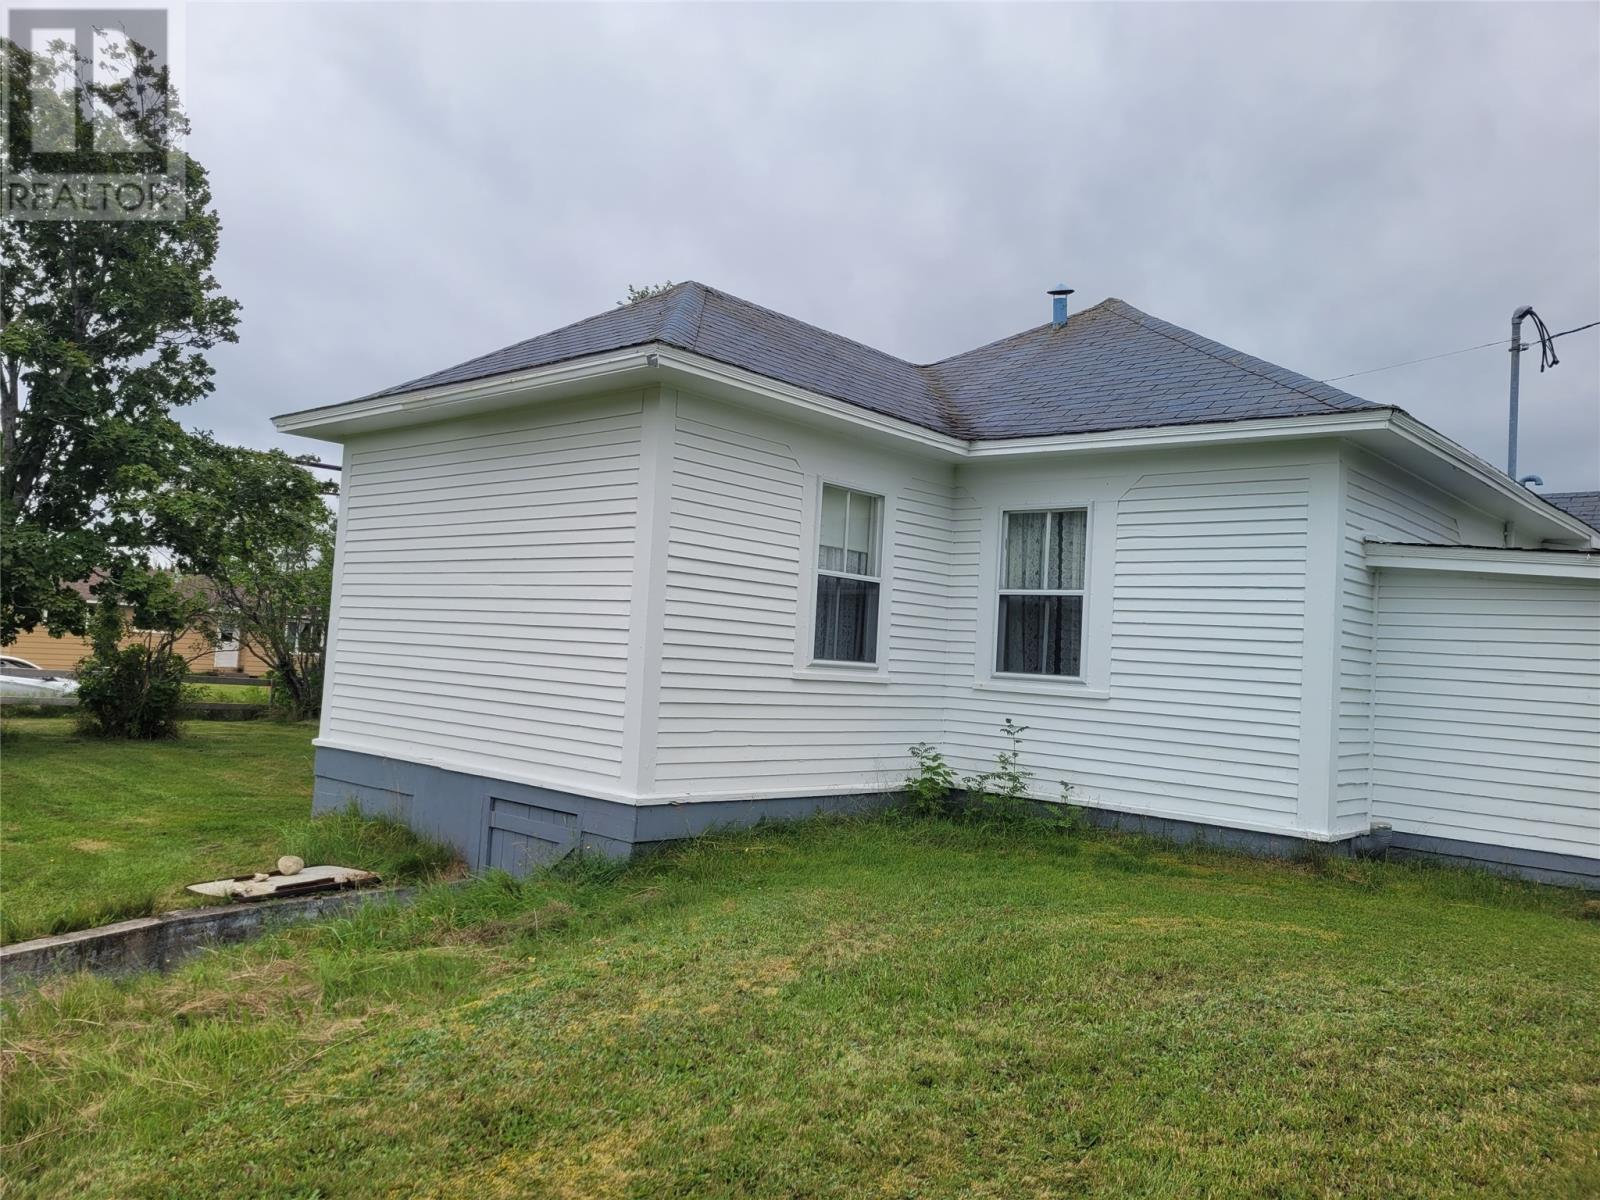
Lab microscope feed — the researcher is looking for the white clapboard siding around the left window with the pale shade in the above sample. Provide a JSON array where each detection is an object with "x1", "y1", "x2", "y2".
[{"x1": 654, "y1": 395, "x2": 971, "y2": 795}]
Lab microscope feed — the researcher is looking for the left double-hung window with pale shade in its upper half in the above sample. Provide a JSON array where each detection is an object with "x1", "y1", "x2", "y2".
[{"x1": 813, "y1": 483, "x2": 883, "y2": 662}]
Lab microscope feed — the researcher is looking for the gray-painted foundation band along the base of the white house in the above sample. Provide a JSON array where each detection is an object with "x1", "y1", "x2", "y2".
[{"x1": 312, "y1": 749, "x2": 1600, "y2": 888}]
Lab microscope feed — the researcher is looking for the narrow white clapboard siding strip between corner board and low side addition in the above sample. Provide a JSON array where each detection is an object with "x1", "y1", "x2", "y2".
[{"x1": 1334, "y1": 461, "x2": 1461, "y2": 830}]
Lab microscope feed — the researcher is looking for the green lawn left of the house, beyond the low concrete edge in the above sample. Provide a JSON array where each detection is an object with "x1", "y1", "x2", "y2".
[{"x1": 0, "y1": 717, "x2": 451, "y2": 942}]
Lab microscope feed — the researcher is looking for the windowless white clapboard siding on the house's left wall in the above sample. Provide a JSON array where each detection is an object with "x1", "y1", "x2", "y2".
[{"x1": 323, "y1": 397, "x2": 640, "y2": 786}]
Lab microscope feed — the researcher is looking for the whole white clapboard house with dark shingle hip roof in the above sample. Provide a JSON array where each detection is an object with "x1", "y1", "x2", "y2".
[{"x1": 277, "y1": 283, "x2": 1600, "y2": 883}]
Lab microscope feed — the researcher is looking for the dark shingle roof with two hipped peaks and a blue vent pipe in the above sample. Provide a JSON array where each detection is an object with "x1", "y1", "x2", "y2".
[{"x1": 374, "y1": 283, "x2": 1378, "y2": 438}]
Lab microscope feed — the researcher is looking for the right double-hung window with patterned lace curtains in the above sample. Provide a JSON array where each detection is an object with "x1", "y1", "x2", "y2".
[{"x1": 995, "y1": 509, "x2": 1088, "y2": 678}]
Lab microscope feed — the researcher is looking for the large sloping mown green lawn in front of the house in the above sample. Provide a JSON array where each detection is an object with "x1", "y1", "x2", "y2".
[{"x1": 3, "y1": 819, "x2": 1600, "y2": 1197}]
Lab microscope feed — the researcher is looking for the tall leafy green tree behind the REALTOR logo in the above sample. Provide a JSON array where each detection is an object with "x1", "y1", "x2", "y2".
[{"x1": 0, "y1": 32, "x2": 238, "y2": 643}]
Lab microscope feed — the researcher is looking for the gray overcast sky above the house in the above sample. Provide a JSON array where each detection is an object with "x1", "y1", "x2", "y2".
[{"x1": 186, "y1": 3, "x2": 1600, "y2": 490}]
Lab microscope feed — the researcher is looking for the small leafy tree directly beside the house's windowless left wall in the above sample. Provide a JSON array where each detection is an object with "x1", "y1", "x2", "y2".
[{"x1": 148, "y1": 435, "x2": 338, "y2": 718}]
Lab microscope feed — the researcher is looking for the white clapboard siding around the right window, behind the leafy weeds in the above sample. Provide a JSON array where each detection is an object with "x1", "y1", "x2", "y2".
[{"x1": 949, "y1": 466, "x2": 1309, "y2": 829}]
